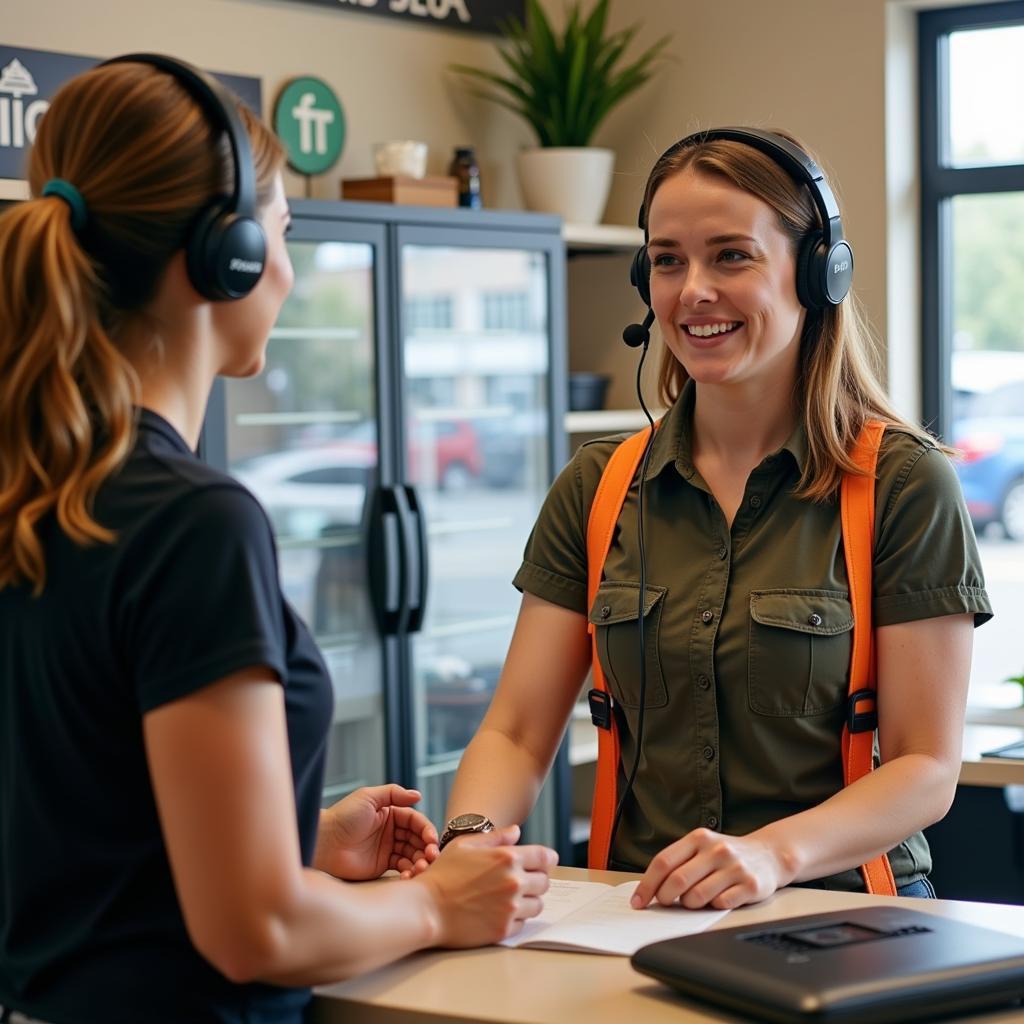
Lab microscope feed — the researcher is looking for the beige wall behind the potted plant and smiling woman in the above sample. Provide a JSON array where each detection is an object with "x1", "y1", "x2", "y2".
[{"x1": 3, "y1": 0, "x2": 942, "y2": 414}]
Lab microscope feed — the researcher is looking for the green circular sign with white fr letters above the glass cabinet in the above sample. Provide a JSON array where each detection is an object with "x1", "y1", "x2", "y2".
[{"x1": 273, "y1": 78, "x2": 345, "y2": 174}]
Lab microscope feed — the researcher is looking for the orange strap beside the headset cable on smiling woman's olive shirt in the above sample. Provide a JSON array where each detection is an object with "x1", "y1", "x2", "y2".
[{"x1": 587, "y1": 427, "x2": 650, "y2": 868}]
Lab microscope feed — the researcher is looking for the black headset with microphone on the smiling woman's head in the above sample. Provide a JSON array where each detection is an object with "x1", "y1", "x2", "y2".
[{"x1": 623, "y1": 128, "x2": 853, "y2": 348}]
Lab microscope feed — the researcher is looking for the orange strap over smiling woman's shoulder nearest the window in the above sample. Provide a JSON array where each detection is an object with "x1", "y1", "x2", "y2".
[{"x1": 840, "y1": 420, "x2": 896, "y2": 896}]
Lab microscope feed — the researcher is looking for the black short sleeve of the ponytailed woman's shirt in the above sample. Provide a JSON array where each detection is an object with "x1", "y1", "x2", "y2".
[{"x1": 117, "y1": 485, "x2": 287, "y2": 714}]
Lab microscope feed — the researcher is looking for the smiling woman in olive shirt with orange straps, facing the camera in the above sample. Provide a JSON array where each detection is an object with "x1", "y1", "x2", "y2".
[{"x1": 449, "y1": 129, "x2": 991, "y2": 907}]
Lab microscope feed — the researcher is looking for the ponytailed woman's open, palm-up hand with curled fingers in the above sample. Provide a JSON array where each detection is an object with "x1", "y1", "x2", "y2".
[{"x1": 313, "y1": 784, "x2": 438, "y2": 882}]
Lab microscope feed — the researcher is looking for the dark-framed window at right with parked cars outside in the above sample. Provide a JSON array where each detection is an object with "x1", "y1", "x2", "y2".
[{"x1": 918, "y1": 6, "x2": 1024, "y2": 721}]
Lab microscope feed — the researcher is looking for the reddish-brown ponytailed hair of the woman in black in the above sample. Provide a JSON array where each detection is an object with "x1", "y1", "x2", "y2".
[{"x1": 0, "y1": 63, "x2": 283, "y2": 594}]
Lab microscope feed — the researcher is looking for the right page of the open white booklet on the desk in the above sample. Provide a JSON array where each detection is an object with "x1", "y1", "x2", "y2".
[{"x1": 520, "y1": 882, "x2": 729, "y2": 956}]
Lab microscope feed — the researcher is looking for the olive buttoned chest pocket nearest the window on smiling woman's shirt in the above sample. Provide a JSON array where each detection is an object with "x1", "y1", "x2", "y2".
[{"x1": 746, "y1": 590, "x2": 853, "y2": 718}]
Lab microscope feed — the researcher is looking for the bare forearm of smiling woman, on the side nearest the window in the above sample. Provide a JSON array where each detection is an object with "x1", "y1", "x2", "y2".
[{"x1": 754, "y1": 754, "x2": 956, "y2": 882}]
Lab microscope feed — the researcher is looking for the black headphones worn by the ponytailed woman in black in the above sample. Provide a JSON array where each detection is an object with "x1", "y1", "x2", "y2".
[{"x1": 103, "y1": 53, "x2": 266, "y2": 301}]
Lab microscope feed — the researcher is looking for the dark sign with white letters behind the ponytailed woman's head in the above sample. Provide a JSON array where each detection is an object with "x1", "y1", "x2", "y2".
[{"x1": 0, "y1": 44, "x2": 262, "y2": 178}]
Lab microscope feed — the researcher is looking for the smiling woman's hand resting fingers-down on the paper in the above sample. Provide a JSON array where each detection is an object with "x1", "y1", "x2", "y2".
[{"x1": 631, "y1": 828, "x2": 792, "y2": 910}]
